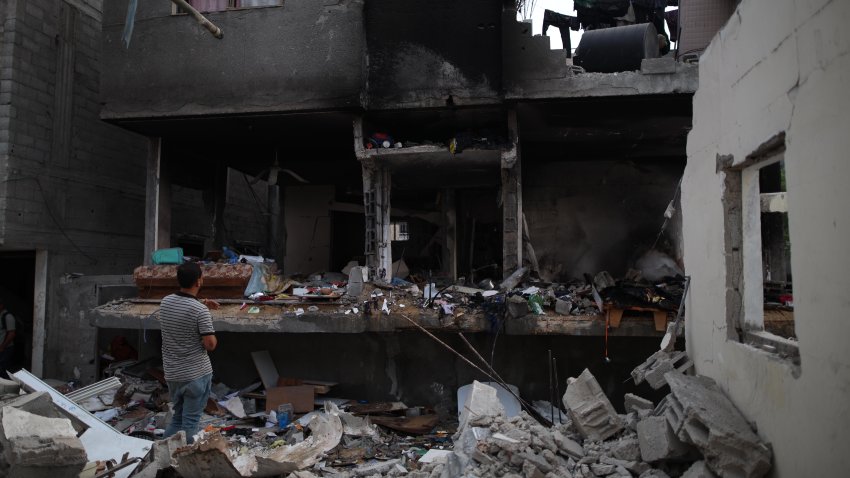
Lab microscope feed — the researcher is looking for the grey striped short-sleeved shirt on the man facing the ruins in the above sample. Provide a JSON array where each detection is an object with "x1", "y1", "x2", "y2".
[{"x1": 159, "y1": 292, "x2": 215, "y2": 382}]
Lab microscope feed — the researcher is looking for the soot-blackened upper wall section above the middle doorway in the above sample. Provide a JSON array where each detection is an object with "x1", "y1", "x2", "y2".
[{"x1": 364, "y1": 0, "x2": 502, "y2": 107}]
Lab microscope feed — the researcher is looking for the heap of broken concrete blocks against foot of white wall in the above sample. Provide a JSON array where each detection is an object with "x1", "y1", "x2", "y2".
[{"x1": 402, "y1": 370, "x2": 771, "y2": 478}]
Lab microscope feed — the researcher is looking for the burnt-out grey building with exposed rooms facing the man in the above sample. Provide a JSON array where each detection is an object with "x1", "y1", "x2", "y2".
[{"x1": 78, "y1": 1, "x2": 707, "y2": 410}]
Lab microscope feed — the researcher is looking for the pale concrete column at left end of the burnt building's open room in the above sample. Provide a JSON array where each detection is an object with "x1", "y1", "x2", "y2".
[{"x1": 144, "y1": 138, "x2": 171, "y2": 264}]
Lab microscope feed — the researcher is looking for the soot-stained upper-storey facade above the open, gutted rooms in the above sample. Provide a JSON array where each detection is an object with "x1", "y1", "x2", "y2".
[{"x1": 101, "y1": 0, "x2": 708, "y2": 121}]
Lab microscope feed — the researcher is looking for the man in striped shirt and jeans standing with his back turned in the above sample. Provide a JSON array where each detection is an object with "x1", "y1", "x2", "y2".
[{"x1": 159, "y1": 262, "x2": 218, "y2": 443}]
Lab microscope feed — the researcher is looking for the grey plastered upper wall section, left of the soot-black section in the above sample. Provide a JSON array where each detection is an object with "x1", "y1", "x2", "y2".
[{"x1": 102, "y1": 0, "x2": 365, "y2": 119}]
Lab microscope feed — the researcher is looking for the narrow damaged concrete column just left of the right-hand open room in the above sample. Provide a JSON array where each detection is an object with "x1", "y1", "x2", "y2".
[{"x1": 502, "y1": 110, "x2": 522, "y2": 277}]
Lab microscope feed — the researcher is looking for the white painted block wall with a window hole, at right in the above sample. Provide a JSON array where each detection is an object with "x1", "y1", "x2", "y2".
[{"x1": 682, "y1": 0, "x2": 850, "y2": 477}]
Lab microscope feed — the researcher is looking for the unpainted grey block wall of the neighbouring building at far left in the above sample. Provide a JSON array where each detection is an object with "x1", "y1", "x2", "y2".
[{"x1": 0, "y1": 0, "x2": 147, "y2": 377}]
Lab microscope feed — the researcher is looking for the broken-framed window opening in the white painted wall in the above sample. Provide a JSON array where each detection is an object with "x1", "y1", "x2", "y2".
[{"x1": 719, "y1": 134, "x2": 800, "y2": 364}]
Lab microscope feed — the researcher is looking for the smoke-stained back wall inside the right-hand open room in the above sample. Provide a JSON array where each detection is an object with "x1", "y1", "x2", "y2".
[{"x1": 523, "y1": 160, "x2": 682, "y2": 280}]
